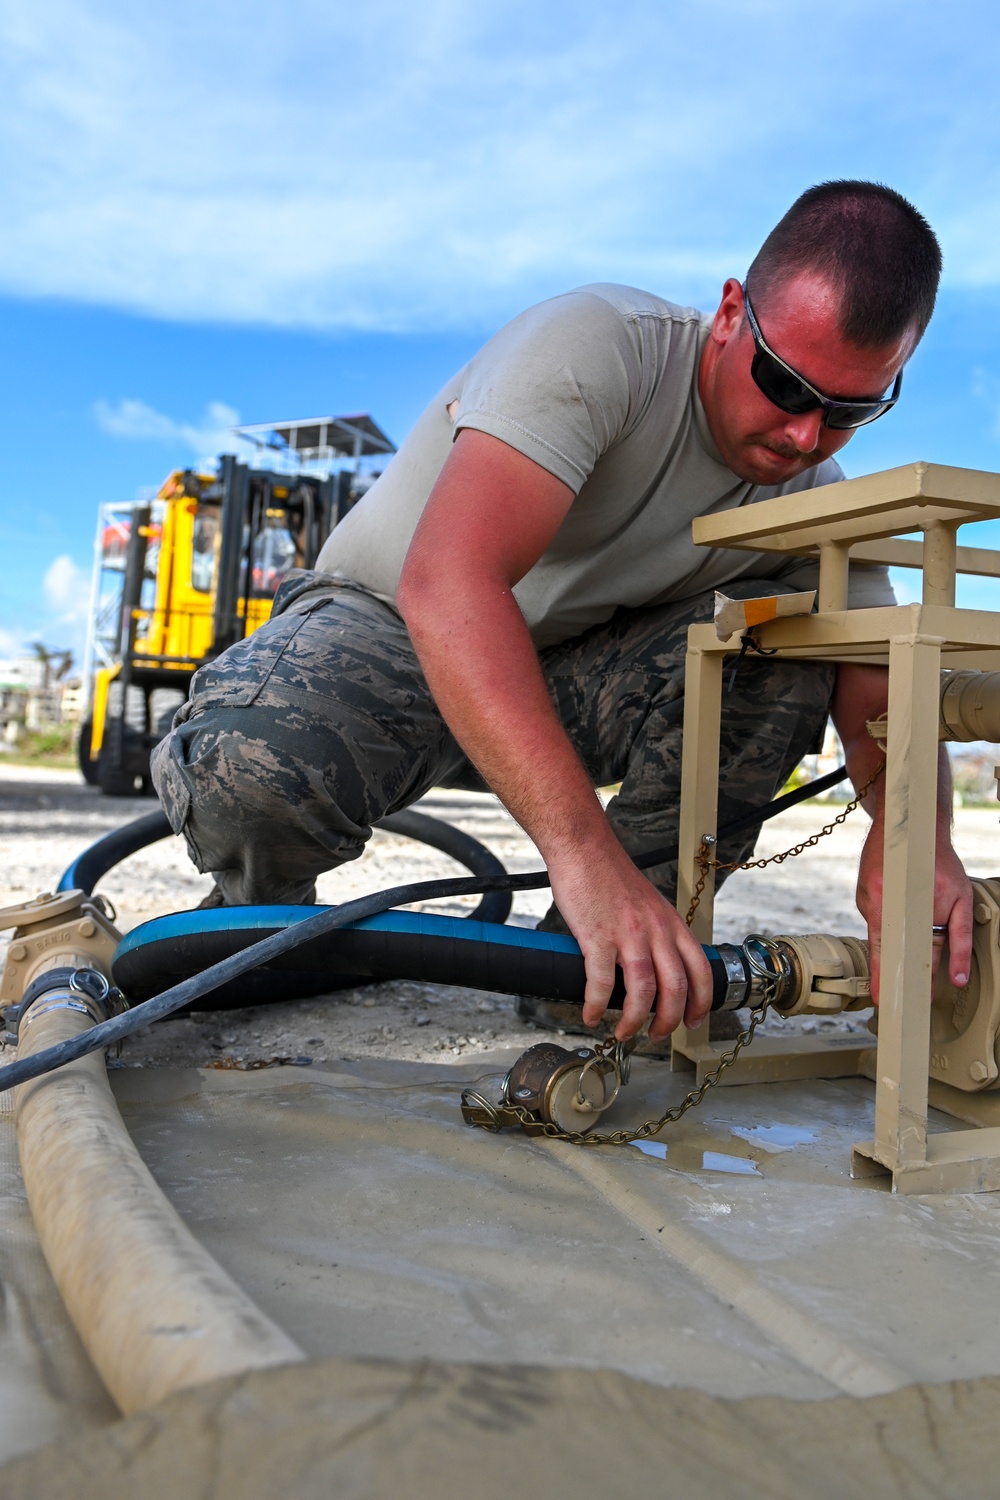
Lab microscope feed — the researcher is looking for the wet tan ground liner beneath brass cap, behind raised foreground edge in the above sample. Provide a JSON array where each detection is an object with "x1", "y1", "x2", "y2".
[{"x1": 0, "y1": 1052, "x2": 1000, "y2": 1458}]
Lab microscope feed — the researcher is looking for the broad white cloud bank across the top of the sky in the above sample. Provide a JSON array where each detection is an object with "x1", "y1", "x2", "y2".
[{"x1": 0, "y1": 0, "x2": 1000, "y2": 329}]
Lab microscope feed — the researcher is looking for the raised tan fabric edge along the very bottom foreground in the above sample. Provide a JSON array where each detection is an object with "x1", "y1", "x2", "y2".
[{"x1": 0, "y1": 1359, "x2": 1000, "y2": 1500}]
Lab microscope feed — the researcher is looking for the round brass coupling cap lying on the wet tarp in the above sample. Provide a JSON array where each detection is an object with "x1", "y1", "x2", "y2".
[{"x1": 462, "y1": 1041, "x2": 634, "y2": 1136}]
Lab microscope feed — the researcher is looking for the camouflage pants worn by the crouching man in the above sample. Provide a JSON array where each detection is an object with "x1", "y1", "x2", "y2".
[{"x1": 153, "y1": 572, "x2": 835, "y2": 906}]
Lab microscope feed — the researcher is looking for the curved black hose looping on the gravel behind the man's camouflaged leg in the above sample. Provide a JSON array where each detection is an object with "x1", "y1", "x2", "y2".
[{"x1": 55, "y1": 809, "x2": 513, "y2": 923}]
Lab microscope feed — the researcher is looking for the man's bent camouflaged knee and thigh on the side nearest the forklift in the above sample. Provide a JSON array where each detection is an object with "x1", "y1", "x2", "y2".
[{"x1": 153, "y1": 582, "x2": 462, "y2": 899}]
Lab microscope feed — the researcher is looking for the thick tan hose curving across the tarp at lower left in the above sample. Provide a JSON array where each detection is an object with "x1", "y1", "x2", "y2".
[{"x1": 13, "y1": 987, "x2": 304, "y2": 1416}]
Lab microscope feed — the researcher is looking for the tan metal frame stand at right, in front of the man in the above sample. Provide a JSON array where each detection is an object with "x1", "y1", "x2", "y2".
[{"x1": 672, "y1": 464, "x2": 1000, "y2": 1193}]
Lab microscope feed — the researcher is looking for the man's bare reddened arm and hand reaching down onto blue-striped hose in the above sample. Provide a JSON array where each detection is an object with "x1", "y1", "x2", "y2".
[{"x1": 400, "y1": 564, "x2": 712, "y2": 1040}]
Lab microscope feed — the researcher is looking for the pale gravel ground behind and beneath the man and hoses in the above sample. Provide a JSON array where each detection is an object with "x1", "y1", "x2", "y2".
[{"x1": 0, "y1": 765, "x2": 1000, "y2": 1067}]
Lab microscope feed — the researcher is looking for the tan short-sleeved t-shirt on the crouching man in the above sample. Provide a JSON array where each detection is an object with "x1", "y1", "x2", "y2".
[{"x1": 316, "y1": 284, "x2": 894, "y2": 647}]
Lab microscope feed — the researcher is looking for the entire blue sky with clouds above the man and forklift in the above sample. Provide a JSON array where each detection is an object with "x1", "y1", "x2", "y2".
[{"x1": 0, "y1": 0, "x2": 1000, "y2": 656}]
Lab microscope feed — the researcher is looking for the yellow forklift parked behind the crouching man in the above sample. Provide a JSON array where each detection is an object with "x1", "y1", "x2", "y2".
[{"x1": 79, "y1": 416, "x2": 394, "y2": 797}]
